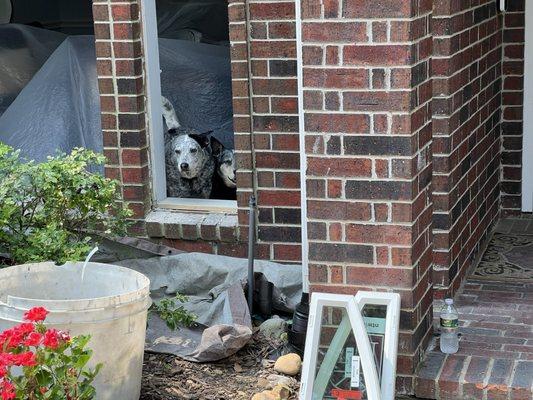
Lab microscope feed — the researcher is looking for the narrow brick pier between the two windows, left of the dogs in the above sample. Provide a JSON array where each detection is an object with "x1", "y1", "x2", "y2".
[{"x1": 93, "y1": 0, "x2": 150, "y2": 232}]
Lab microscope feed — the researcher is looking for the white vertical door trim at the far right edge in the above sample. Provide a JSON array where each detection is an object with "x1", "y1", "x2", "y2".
[{"x1": 522, "y1": 0, "x2": 533, "y2": 212}]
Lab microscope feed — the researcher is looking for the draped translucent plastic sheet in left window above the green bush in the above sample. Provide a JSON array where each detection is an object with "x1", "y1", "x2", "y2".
[{"x1": 0, "y1": 36, "x2": 102, "y2": 161}]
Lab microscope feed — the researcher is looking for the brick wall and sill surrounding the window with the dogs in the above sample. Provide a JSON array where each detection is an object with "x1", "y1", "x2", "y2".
[{"x1": 93, "y1": 0, "x2": 301, "y2": 262}]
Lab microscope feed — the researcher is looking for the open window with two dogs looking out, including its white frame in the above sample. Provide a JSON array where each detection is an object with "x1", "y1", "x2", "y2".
[{"x1": 141, "y1": 0, "x2": 237, "y2": 212}]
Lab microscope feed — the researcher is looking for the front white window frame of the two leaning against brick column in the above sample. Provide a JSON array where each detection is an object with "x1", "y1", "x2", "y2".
[{"x1": 299, "y1": 293, "x2": 382, "y2": 400}]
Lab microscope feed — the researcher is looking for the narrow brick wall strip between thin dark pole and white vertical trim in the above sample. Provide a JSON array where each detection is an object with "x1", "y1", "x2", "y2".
[{"x1": 247, "y1": 0, "x2": 301, "y2": 262}]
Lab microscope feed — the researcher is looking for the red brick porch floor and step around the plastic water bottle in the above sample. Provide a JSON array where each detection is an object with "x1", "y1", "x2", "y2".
[{"x1": 415, "y1": 221, "x2": 533, "y2": 400}]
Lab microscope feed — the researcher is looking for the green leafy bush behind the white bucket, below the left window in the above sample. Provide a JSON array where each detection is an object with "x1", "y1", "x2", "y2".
[{"x1": 0, "y1": 143, "x2": 131, "y2": 264}]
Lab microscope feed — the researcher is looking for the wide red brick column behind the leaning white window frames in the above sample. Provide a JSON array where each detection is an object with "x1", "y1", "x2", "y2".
[{"x1": 302, "y1": 0, "x2": 432, "y2": 393}]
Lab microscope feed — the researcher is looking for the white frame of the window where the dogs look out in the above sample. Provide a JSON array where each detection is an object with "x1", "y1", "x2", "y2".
[{"x1": 140, "y1": 0, "x2": 237, "y2": 214}]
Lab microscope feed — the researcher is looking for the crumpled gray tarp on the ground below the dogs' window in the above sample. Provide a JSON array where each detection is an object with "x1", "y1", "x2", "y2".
[{"x1": 116, "y1": 253, "x2": 302, "y2": 362}]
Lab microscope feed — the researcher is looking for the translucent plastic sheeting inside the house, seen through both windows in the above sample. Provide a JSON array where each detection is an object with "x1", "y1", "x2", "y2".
[{"x1": 0, "y1": 25, "x2": 233, "y2": 161}]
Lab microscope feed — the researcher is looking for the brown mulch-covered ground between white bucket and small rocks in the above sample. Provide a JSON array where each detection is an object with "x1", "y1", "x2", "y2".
[{"x1": 140, "y1": 335, "x2": 299, "y2": 400}]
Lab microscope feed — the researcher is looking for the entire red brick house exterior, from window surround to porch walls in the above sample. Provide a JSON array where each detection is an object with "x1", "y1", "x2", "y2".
[{"x1": 93, "y1": 0, "x2": 524, "y2": 393}]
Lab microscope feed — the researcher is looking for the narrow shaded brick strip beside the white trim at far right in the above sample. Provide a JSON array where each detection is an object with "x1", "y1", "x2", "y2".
[{"x1": 501, "y1": 0, "x2": 525, "y2": 215}]
